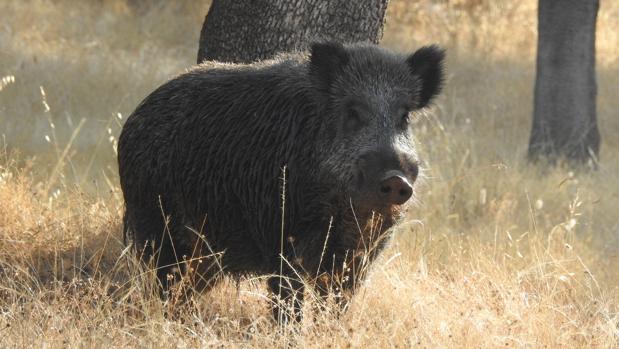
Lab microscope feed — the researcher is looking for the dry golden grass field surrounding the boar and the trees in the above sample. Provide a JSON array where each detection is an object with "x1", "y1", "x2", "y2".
[{"x1": 0, "y1": 0, "x2": 619, "y2": 348}]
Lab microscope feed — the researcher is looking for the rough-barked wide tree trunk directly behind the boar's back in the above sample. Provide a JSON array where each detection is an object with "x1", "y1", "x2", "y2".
[{"x1": 198, "y1": 0, "x2": 389, "y2": 63}]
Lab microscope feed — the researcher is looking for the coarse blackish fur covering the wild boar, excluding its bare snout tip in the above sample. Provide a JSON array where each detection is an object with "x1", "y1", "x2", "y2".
[{"x1": 118, "y1": 42, "x2": 444, "y2": 317}]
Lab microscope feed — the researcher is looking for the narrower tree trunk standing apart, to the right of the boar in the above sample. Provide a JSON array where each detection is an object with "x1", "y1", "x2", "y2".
[{"x1": 529, "y1": 0, "x2": 600, "y2": 165}]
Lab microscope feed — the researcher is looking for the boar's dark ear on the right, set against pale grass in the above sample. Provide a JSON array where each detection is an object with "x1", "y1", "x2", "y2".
[{"x1": 406, "y1": 45, "x2": 445, "y2": 108}]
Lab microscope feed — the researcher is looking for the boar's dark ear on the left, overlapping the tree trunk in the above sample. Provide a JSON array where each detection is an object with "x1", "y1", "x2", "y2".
[{"x1": 309, "y1": 42, "x2": 348, "y2": 90}]
